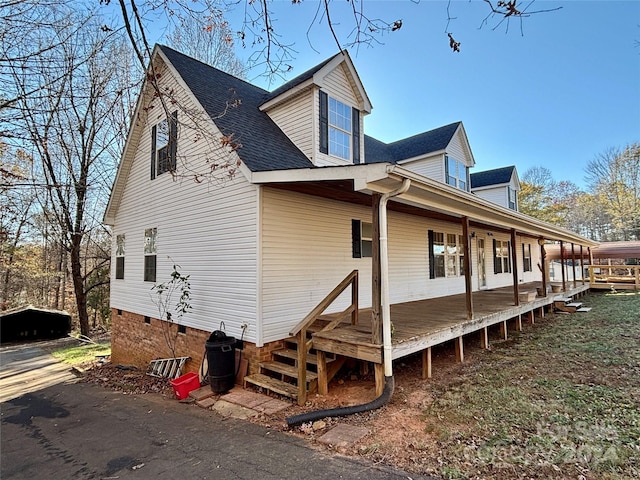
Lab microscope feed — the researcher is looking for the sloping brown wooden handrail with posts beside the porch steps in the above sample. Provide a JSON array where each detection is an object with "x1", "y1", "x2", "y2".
[{"x1": 289, "y1": 270, "x2": 358, "y2": 405}]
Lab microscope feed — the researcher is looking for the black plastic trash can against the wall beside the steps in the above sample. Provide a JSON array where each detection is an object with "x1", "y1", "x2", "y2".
[{"x1": 205, "y1": 330, "x2": 236, "y2": 393}]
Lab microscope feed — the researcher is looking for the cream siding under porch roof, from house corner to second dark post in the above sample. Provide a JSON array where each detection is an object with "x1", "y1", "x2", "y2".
[{"x1": 262, "y1": 188, "x2": 480, "y2": 342}]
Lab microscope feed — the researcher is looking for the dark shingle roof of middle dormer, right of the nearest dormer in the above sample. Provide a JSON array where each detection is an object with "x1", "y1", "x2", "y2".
[{"x1": 364, "y1": 122, "x2": 461, "y2": 163}]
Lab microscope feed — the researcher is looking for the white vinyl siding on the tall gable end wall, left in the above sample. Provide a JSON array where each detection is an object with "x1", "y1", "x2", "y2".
[{"x1": 111, "y1": 68, "x2": 258, "y2": 341}]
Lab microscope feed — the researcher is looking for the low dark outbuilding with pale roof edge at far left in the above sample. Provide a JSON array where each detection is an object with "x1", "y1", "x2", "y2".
[{"x1": 0, "y1": 305, "x2": 71, "y2": 343}]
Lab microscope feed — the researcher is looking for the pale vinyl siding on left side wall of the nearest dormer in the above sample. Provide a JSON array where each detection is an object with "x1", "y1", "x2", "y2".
[{"x1": 267, "y1": 89, "x2": 317, "y2": 159}]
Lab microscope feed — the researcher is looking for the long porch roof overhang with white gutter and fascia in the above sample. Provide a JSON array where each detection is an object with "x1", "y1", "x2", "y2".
[{"x1": 251, "y1": 163, "x2": 598, "y2": 246}]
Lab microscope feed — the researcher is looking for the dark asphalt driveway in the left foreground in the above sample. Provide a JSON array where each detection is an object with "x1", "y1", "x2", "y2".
[{"x1": 0, "y1": 344, "x2": 426, "y2": 480}]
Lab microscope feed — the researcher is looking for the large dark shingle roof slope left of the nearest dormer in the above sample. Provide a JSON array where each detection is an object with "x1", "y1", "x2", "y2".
[{"x1": 159, "y1": 46, "x2": 313, "y2": 172}]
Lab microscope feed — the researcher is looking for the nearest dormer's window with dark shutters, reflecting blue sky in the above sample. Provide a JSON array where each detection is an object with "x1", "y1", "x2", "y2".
[{"x1": 320, "y1": 91, "x2": 360, "y2": 163}]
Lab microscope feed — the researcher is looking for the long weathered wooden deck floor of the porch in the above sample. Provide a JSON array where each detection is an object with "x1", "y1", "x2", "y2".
[{"x1": 313, "y1": 282, "x2": 589, "y2": 364}]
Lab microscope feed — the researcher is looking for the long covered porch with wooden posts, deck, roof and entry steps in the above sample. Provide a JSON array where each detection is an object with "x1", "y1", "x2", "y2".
[{"x1": 249, "y1": 164, "x2": 596, "y2": 405}]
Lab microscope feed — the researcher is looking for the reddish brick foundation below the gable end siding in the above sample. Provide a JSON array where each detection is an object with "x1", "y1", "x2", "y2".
[{"x1": 111, "y1": 308, "x2": 284, "y2": 374}]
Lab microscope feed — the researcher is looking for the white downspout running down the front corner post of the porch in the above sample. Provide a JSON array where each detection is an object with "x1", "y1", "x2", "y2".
[{"x1": 378, "y1": 178, "x2": 411, "y2": 377}]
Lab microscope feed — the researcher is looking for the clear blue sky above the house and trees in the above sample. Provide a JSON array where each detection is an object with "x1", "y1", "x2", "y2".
[{"x1": 221, "y1": 0, "x2": 640, "y2": 187}]
